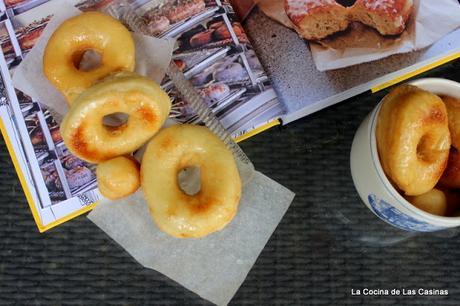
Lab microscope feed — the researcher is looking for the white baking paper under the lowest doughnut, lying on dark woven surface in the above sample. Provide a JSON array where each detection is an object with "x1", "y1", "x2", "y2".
[{"x1": 88, "y1": 172, "x2": 294, "y2": 305}]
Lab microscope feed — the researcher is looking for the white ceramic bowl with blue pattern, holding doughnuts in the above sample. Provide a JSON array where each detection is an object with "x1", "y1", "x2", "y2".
[{"x1": 350, "y1": 78, "x2": 460, "y2": 232}]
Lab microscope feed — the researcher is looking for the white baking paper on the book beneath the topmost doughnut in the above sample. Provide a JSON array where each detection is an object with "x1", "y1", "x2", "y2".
[{"x1": 13, "y1": 1, "x2": 175, "y2": 121}]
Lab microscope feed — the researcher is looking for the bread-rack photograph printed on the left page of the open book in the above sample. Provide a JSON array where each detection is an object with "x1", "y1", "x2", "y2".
[{"x1": 0, "y1": 0, "x2": 283, "y2": 227}]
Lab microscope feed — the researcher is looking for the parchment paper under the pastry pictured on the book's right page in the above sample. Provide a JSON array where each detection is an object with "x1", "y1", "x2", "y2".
[{"x1": 256, "y1": 0, "x2": 460, "y2": 71}]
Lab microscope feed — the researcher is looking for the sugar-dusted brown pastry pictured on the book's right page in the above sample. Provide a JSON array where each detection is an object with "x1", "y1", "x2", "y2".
[{"x1": 284, "y1": 0, "x2": 413, "y2": 40}]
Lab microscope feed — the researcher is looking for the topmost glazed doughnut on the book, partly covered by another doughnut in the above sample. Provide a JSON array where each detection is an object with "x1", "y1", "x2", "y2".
[{"x1": 43, "y1": 12, "x2": 135, "y2": 104}]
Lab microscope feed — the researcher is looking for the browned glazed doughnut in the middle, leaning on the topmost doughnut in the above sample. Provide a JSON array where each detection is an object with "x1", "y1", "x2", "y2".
[{"x1": 61, "y1": 72, "x2": 171, "y2": 163}]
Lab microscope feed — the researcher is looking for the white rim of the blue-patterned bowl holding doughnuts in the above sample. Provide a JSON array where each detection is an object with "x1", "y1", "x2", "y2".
[{"x1": 369, "y1": 78, "x2": 460, "y2": 225}]
